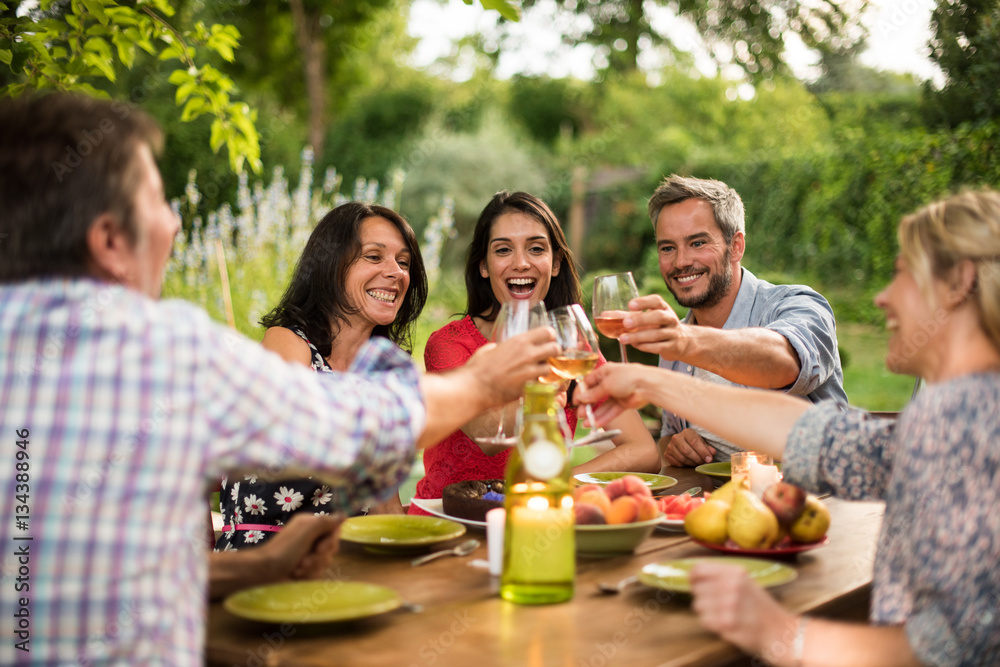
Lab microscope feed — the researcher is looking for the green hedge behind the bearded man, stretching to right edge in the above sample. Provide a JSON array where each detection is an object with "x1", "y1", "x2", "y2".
[{"x1": 585, "y1": 121, "x2": 1000, "y2": 323}]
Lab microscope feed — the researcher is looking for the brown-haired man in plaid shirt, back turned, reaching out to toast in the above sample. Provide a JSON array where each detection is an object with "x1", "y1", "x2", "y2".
[{"x1": 0, "y1": 94, "x2": 556, "y2": 665}]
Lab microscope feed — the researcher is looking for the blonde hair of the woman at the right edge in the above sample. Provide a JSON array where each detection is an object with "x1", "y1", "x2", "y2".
[{"x1": 899, "y1": 190, "x2": 1000, "y2": 349}]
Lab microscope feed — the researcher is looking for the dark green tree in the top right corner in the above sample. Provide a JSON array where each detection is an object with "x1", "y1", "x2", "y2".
[{"x1": 926, "y1": 0, "x2": 1000, "y2": 126}]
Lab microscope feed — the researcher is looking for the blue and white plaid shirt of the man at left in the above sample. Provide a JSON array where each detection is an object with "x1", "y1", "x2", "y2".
[{"x1": 0, "y1": 279, "x2": 425, "y2": 665}]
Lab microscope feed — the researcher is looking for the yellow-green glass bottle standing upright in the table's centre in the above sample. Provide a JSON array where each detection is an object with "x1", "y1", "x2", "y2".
[{"x1": 500, "y1": 382, "x2": 576, "y2": 604}]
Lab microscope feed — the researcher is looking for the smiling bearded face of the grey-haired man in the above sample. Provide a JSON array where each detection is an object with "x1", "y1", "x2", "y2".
[{"x1": 656, "y1": 199, "x2": 743, "y2": 309}]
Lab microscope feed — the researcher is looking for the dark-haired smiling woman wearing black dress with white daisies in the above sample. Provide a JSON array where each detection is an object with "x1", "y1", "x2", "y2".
[{"x1": 216, "y1": 202, "x2": 427, "y2": 550}]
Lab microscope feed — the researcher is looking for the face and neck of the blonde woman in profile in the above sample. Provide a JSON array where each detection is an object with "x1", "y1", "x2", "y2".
[{"x1": 875, "y1": 257, "x2": 947, "y2": 378}]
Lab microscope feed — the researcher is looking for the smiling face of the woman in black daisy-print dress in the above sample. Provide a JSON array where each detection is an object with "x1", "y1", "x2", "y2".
[{"x1": 347, "y1": 217, "x2": 411, "y2": 331}]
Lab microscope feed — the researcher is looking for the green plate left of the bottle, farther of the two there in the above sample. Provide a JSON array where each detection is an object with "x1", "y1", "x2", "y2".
[{"x1": 340, "y1": 514, "x2": 465, "y2": 552}]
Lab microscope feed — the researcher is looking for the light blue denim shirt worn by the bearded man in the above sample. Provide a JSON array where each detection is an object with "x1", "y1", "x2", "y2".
[{"x1": 660, "y1": 268, "x2": 847, "y2": 461}]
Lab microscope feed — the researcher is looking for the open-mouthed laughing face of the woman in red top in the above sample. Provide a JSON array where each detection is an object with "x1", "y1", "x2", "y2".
[{"x1": 479, "y1": 211, "x2": 560, "y2": 304}]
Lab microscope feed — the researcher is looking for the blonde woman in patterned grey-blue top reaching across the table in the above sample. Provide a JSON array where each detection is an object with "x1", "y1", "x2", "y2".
[{"x1": 580, "y1": 192, "x2": 1000, "y2": 667}]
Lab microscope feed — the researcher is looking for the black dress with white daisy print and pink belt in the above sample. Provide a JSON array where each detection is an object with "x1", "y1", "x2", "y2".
[{"x1": 215, "y1": 327, "x2": 336, "y2": 551}]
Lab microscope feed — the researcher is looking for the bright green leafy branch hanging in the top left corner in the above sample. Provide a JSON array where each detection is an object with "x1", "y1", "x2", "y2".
[{"x1": 0, "y1": 0, "x2": 261, "y2": 172}]
